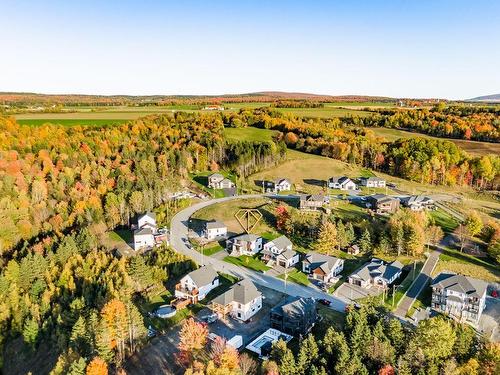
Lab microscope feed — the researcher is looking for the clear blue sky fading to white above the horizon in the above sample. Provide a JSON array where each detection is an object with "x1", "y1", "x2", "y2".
[{"x1": 0, "y1": 0, "x2": 500, "y2": 99}]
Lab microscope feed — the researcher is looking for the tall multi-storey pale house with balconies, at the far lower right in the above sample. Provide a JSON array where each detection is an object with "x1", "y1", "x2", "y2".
[{"x1": 431, "y1": 273, "x2": 488, "y2": 325}]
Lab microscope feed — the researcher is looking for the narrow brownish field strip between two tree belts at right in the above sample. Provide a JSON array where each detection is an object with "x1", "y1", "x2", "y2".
[{"x1": 367, "y1": 128, "x2": 500, "y2": 155}]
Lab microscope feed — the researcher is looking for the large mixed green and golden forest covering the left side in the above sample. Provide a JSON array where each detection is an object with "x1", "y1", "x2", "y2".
[{"x1": 0, "y1": 113, "x2": 286, "y2": 374}]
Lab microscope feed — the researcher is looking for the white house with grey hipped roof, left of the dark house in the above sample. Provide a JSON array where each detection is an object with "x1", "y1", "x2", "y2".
[{"x1": 212, "y1": 279, "x2": 262, "y2": 322}]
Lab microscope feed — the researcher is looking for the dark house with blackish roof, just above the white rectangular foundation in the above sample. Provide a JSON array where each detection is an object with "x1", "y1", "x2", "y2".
[{"x1": 270, "y1": 296, "x2": 317, "y2": 336}]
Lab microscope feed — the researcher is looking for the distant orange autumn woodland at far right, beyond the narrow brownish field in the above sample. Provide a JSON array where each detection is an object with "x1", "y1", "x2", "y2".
[{"x1": 360, "y1": 103, "x2": 500, "y2": 142}]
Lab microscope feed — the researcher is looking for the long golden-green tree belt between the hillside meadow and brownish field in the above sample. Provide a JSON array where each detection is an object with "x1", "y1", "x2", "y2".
[{"x1": 224, "y1": 108, "x2": 500, "y2": 189}]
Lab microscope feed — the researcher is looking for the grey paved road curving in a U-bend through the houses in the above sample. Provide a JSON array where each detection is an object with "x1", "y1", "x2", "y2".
[{"x1": 170, "y1": 194, "x2": 347, "y2": 312}]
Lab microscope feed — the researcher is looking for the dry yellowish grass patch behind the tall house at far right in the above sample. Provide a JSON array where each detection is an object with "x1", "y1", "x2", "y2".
[{"x1": 432, "y1": 249, "x2": 500, "y2": 283}]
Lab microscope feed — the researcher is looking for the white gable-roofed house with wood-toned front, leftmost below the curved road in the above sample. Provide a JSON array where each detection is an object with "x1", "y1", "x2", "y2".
[{"x1": 175, "y1": 266, "x2": 219, "y2": 303}]
